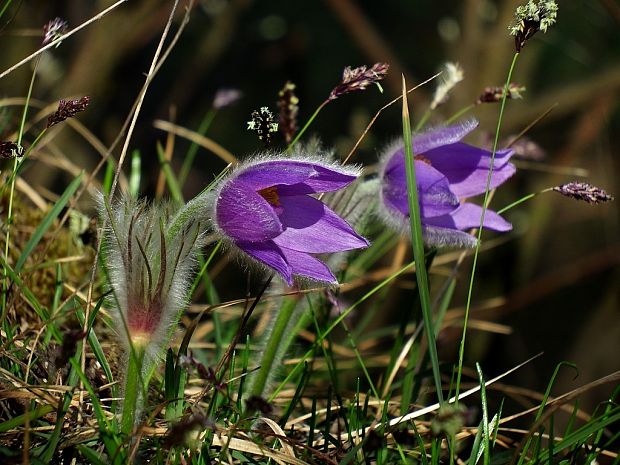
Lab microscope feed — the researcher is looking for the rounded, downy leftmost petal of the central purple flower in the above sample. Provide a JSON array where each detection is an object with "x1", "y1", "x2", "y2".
[{"x1": 216, "y1": 179, "x2": 282, "y2": 242}]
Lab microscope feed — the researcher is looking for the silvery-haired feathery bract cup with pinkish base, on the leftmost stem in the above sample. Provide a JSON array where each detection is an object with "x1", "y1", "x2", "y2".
[{"x1": 97, "y1": 193, "x2": 203, "y2": 371}]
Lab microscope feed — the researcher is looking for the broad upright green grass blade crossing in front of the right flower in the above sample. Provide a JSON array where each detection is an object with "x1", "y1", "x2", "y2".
[{"x1": 403, "y1": 76, "x2": 443, "y2": 403}]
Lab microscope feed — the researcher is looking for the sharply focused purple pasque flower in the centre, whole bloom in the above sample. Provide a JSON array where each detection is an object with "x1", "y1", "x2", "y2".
[{"x1": 211, "y1": 158, "x2": 368, "y2": 285}]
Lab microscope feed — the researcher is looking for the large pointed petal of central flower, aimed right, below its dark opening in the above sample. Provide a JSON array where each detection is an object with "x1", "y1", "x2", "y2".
[{"x1": 273, "y1": 195, "x2": 368, "y2": 253}]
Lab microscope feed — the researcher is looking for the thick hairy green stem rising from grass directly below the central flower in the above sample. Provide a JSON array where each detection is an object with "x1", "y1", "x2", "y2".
[{"x1": 250, "y1": 299, "x2": 298, "y2": 397}]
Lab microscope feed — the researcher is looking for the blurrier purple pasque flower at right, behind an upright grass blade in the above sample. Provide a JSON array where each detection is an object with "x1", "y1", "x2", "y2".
[{"x1": 379, "y1": 120, "x2": 515, "y2": 247}]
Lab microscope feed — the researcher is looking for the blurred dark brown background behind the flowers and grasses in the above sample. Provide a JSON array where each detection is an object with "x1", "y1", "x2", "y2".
[{"x1": 0, "y1": 0, "x2": 620, "y2": 410}]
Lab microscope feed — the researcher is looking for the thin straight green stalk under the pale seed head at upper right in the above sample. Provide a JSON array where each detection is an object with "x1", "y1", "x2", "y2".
[{"x1": 454, "y1": 52, "x2": 519, "y2": 403}]
